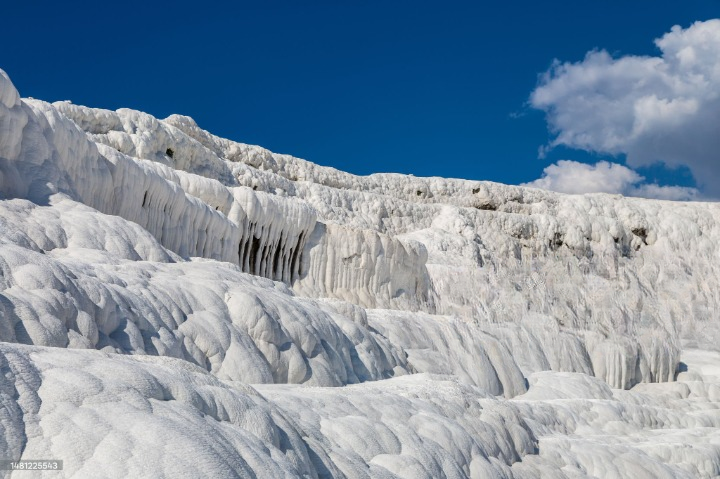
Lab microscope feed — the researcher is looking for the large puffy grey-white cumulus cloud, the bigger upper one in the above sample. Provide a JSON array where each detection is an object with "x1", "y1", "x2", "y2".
[{"x1": 530, "y1": 20, "x2": 720, "y2": 196}]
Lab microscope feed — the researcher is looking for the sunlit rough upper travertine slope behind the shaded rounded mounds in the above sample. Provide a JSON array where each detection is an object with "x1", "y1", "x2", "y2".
[{"x1": 55, "y1": 91, "x2": 720, "y2": 387}]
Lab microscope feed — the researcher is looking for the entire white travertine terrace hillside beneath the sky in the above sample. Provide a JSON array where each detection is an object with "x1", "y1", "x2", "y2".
[{"x1": 0, "y1": 70, "x2": 720, "y2": 478}]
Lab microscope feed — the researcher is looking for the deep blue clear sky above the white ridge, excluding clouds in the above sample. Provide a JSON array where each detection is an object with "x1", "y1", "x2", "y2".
[{"x1": 0, "y1": 0, "x2": 720, "y2": 197}]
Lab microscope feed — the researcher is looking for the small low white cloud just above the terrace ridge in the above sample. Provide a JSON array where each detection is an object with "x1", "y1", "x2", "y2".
[{"x1": 523, "y1": 160, "x2": 699, "y2": 200}]
